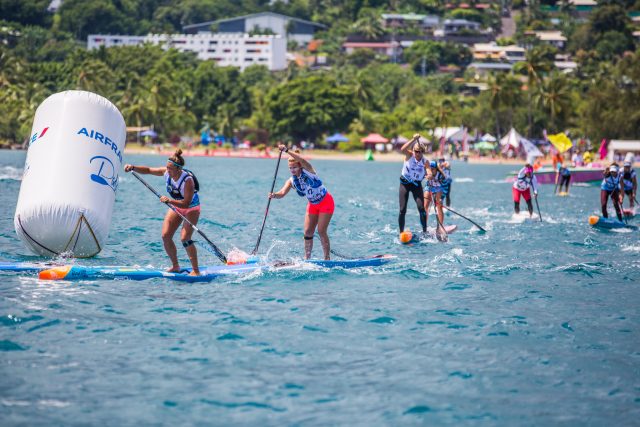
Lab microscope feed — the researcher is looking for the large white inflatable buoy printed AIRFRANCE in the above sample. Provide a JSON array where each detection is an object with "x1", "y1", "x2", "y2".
[{"x1": 14, "y1": 90, "x2": 126, "y2": 258}]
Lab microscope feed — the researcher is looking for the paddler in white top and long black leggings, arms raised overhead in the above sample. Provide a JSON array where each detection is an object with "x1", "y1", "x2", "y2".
[{"x1": 398, "y1": 134, "x2": 427, "y2": 233}]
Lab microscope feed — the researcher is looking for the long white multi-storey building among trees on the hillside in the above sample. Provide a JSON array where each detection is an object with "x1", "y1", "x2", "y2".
[{"x1": 87, "y1": 33, "x2": 287, "y2": 71}]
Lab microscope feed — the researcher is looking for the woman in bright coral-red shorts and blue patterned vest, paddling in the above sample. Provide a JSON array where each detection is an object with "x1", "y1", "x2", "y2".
[{"x1": 269, "y1": 144, "x2": 335, "y2": 260}]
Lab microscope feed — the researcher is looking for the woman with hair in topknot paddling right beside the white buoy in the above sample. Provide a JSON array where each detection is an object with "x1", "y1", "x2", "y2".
[{"x1": 124, "y1": 149, "x2": 200, "y2": 276}]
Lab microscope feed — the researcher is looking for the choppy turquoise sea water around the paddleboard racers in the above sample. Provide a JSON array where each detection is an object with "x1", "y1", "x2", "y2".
[{"x1": 0, "y1": 152, "x2": 640, "y2": 425}]
